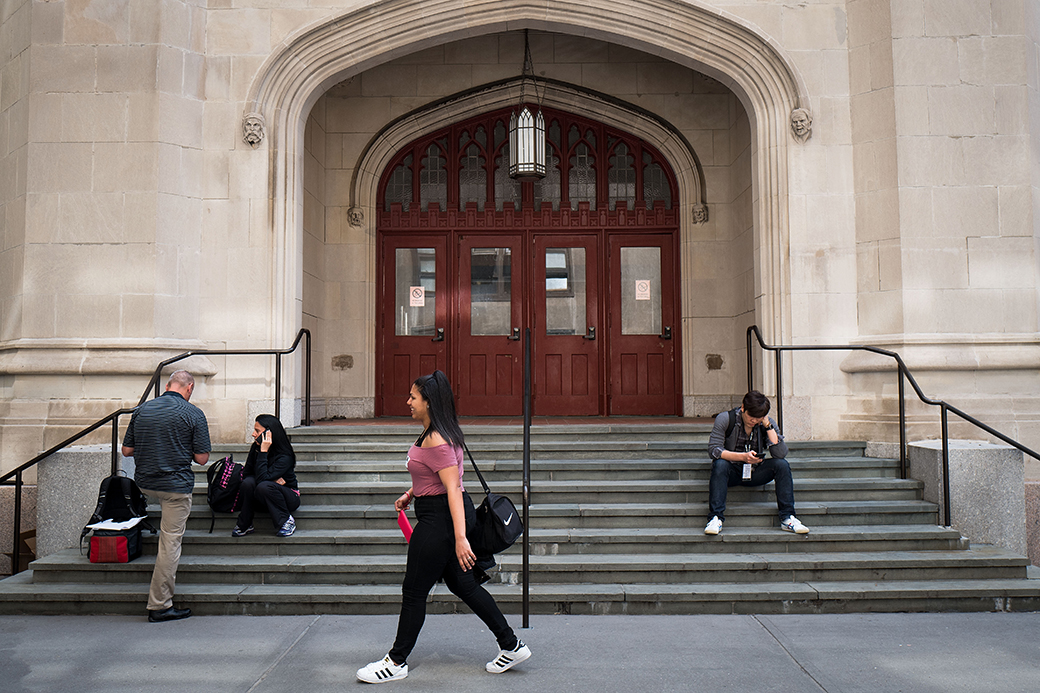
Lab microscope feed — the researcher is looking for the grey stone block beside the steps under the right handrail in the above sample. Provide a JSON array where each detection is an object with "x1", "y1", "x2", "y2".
[{"x1": 908, "y1": 440, "x2": 1026, "y2": 556}]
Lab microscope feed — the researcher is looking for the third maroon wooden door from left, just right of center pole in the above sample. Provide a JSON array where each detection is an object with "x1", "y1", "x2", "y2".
[{"x1": 531, "y1": 234, "x2": 603, "y2": 416}]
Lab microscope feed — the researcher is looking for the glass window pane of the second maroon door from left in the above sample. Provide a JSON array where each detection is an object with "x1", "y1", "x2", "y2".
[{"x1": 469, "y1": 248, "x2": 513, "y2": 336}]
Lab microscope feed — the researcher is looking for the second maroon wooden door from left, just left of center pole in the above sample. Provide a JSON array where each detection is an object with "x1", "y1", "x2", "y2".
[{"x1": 452, "y1": 234, "x2": 526, "y2": 416}]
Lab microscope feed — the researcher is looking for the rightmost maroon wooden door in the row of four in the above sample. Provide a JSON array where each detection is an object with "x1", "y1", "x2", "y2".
[{"x1": 607, "y1": 234, "x2": 678, "y2": 415}]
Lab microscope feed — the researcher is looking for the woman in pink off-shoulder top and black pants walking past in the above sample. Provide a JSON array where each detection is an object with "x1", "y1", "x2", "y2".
[{"x1": 358, "y1": 370, "x2": 530, "y2": 684}]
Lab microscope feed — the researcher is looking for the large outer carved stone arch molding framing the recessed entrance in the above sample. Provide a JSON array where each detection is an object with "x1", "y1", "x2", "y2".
[{"x1": 243, "y1": 0, "x2": 809, "y2": 355}]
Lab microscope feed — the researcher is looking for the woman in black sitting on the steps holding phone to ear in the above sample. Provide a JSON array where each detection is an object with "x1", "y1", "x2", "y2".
[{"x1": 231, "y1": 414, "x2": 300, "y2": 537}]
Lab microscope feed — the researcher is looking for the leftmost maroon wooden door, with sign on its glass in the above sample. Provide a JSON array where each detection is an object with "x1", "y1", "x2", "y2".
[{"x1": 376, "y1": 234, "x2": 449, "y2": 416}]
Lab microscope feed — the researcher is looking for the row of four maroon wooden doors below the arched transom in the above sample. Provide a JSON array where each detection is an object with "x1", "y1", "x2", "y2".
[{"x1": 376, "y1": 232, "x2": 678, "y2": 416}]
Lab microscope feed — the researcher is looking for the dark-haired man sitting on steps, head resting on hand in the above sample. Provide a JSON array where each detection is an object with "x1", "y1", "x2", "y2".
[{"x1": 704, "y1": 390, "x2": 809, "y2": 534}]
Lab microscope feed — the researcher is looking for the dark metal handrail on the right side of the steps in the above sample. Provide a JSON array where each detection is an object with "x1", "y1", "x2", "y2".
[{"x1": 747, "y1": 325, "x2": 1040, "y2": 527}]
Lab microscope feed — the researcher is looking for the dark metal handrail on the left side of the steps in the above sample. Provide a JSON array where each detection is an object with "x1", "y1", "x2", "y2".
[{"x1": 0, "y1": 328, "x2": 311, "y2": 575}]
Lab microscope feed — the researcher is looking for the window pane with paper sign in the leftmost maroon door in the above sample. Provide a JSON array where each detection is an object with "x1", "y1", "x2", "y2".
[{"x1": 394, "y1": 248, "x2": 437, "y2": 337}]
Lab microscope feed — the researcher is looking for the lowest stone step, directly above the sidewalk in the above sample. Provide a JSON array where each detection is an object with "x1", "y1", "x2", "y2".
[{"x1": 0, "y1": 571, "x2": 1040, "y2": 615}]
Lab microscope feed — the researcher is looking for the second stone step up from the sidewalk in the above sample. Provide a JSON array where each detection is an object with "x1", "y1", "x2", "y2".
[{"x1": 31, "y1": 536, "x2": 1029, "y2": 585}]
